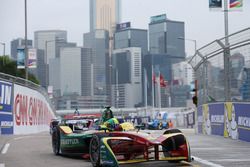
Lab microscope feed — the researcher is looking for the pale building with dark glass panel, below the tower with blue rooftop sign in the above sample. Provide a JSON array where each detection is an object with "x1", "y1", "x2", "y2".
[{"x1": 112, "y1": 47, "x2": 142, "y2": 108}]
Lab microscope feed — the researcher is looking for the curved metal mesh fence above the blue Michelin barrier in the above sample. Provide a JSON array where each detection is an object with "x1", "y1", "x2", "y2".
[{"x1": 189, "y1": 28, "x2": 250, "y2": 105}]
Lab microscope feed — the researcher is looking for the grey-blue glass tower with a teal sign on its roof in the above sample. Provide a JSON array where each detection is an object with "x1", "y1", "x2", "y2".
[{"x1": 149, "y1": 14, "x2": 185, "y2": 59}]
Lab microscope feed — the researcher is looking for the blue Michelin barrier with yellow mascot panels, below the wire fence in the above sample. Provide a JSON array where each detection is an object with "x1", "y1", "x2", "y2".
[{"x1": 198, "y1": 102, "x2": 250, "y2": 142}]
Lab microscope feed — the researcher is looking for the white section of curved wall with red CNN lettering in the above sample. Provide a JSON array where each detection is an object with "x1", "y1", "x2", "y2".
[{"x1": 13, "y1": 84, "x2": 55, "y2": 134}]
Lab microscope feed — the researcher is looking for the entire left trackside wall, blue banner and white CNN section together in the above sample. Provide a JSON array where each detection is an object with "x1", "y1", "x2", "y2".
[{"x1": 0, "y1": 80, "x2": 55, "y2": 135}]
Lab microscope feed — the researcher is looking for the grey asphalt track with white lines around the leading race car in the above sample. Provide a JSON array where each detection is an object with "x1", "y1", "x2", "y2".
[{"x1": 0, "y1": 130, "x2": 250, "y2": 167}]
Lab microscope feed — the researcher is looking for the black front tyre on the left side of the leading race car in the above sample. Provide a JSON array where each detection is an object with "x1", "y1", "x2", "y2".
[{"x1": 89, "y1": 135, "x2": 100, "y2": 167}]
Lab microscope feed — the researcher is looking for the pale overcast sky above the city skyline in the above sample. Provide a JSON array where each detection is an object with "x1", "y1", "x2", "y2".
[{"x1": 0, "y1": 0, "x2": 250, "y2": 55}]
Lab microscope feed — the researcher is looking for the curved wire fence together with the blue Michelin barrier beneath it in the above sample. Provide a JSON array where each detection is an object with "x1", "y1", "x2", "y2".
[{"x1": 189, "y1": 28, "x2": 250, "y2": 141}]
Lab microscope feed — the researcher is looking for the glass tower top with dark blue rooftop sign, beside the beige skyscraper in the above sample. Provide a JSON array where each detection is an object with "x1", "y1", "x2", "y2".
[{"x1": 114, "y1": 25, "x2": 148, "y2": 55}]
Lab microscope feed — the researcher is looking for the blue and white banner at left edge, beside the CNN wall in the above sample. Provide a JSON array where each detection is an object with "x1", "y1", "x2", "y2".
[{"x1": 0, "y1": 81, "x2": 13, "y2": 134}]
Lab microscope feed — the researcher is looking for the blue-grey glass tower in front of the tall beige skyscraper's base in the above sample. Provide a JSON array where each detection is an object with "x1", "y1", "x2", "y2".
[{"x1": 84, "y1": 30, "x2": 109, "y2": 95}]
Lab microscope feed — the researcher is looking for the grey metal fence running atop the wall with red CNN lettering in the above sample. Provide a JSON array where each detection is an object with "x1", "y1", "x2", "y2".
[{"x1": 0, "y1": 72, "x2": 56, "y2": 113}]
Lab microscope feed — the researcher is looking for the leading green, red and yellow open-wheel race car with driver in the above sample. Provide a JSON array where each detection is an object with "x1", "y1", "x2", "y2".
[{"x1": 52, "y1": 107, "x2": 191, "y2": 167}]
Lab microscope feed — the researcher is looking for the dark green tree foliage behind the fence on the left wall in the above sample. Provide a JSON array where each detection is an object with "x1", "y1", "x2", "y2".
[{"x1": 0, "y1": 56, "x2": 39, "y2": 84}]
